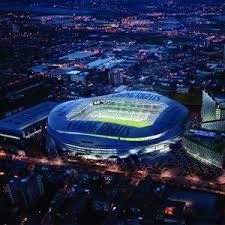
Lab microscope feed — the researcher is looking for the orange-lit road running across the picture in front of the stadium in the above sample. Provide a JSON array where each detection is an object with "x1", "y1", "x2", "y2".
[{"x1": 0, "y1": 151, "x2": 225, "y2": 195}]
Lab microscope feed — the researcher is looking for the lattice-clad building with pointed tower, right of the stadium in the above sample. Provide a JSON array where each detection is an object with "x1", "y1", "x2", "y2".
[{"x1": 182, "y1": 90, "x2": 225, "y2": 168}]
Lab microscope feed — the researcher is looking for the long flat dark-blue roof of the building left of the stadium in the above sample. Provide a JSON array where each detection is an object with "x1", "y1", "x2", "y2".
[{"x1": 0, "y1": 101, "x2": 59, "y2": 135}]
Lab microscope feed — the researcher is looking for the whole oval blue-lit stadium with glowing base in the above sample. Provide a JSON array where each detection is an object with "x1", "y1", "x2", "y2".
[{"x1": 47, "y1": 91, "x2": 188, "y2": 159}]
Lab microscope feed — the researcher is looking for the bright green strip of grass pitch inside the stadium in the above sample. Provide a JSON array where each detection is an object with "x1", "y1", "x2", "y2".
[{"x1": 96, "y1": 117, "x2": 151, "y2": 128}]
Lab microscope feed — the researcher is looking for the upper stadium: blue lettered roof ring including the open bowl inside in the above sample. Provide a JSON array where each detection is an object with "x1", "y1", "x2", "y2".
[{"x1": 48, "y1": 91, "x2": 188, "y2": 141}]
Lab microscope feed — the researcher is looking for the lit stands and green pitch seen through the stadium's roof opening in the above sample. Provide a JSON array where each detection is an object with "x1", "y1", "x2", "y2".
[{"x1": 69, "y1": 98, "x2": 167, "y2": 128}]
